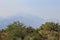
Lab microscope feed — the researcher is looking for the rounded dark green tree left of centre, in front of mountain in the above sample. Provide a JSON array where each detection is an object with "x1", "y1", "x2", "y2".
[{"x1": 6, "y1": 22, "x2": 26, "y2": 40}]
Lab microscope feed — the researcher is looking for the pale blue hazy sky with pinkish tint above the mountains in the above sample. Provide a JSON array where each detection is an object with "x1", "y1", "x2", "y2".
[{"x1": 0, "y1": 0, "x2": 60, "y2": 20}]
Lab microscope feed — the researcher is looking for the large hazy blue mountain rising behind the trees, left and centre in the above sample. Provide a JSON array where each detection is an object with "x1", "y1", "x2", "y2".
[{"x1": 0, "y1": 15, "x2": 45, "y2": 29}]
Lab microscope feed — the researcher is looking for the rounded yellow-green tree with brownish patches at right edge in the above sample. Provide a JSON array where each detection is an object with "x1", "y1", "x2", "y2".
[{"x1": 39, "y1": 22, "x2": 60, "y2": 40}]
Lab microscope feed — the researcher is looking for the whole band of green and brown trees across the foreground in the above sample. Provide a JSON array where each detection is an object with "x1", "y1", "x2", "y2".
[{"x1": 0, "y1": 22, "x2": 60, "y2": 40}]
